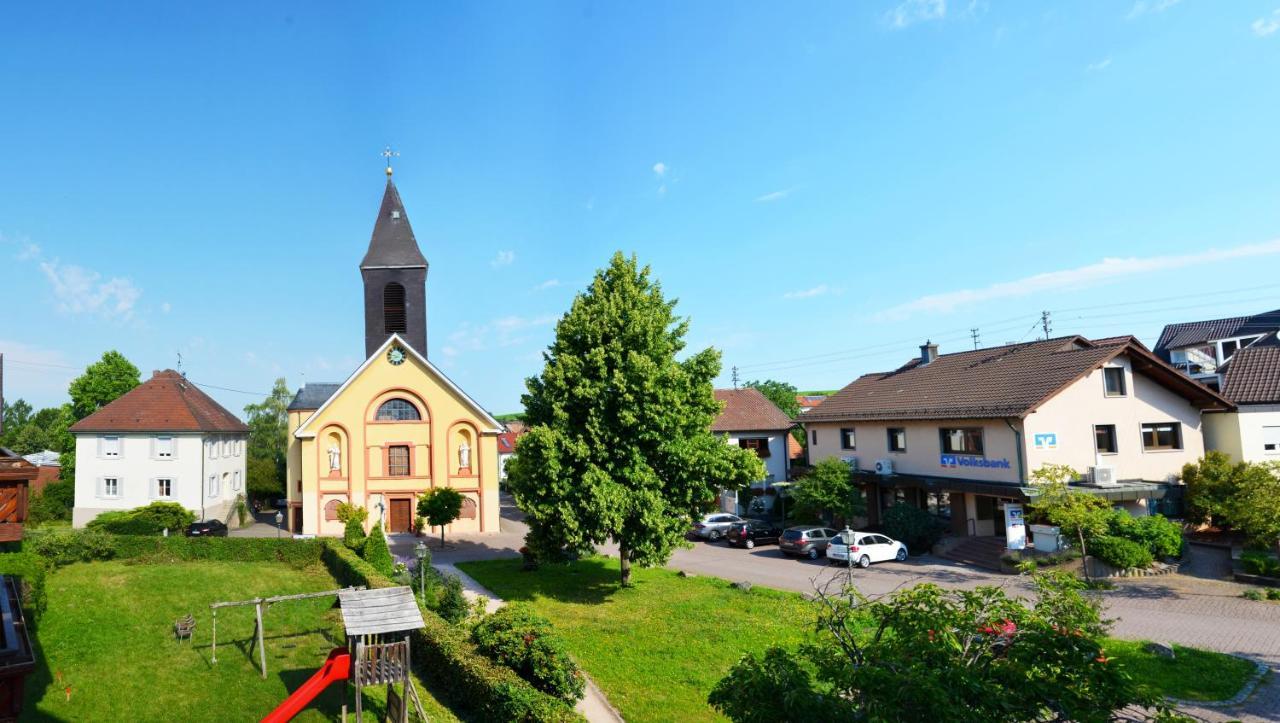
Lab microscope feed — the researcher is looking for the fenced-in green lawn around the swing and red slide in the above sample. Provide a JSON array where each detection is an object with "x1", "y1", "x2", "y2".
[{"x1": 23, "y1": 562, "x2": 457, "y2": 722}]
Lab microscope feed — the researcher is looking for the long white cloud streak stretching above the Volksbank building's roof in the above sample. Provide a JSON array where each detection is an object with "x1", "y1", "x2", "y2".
[{"x1": 877, "y1": 239, "x2": 1280, "y2": 321}]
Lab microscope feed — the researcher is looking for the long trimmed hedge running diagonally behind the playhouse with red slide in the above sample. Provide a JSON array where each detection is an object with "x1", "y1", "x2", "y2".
[{"x1": 320, "y1": 540, "x2": 582, "y2": 722}]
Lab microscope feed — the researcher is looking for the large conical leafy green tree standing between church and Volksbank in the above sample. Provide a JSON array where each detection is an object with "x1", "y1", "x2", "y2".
[{"x1": 507, "y1": 253, "x2": 764, "y2": 585}]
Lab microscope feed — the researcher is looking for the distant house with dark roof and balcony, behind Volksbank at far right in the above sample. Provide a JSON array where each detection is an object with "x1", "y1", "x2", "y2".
[{"x1": 1153, "y1": 308, "x2": 1280, "y2": 389}]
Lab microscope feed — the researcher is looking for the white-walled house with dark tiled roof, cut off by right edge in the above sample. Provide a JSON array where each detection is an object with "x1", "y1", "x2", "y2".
[{"x1": 1204, "y1": 331, "x2": 1280, "y2": 462}]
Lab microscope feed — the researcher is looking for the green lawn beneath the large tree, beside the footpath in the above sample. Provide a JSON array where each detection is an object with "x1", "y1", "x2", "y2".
[{"x1": 458, "y1": 558, "x2": 813, "y2": 723}]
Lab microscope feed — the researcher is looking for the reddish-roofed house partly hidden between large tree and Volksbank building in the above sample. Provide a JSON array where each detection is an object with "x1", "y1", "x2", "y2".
[{"x1": 712, "y1": 388, "x2": 795, "y2": 513}]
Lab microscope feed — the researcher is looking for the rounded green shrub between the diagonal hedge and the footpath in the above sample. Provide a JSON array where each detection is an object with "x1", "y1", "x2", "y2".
[{"x1": 471, "y1": 603, "x2": 586, "y2": 703}]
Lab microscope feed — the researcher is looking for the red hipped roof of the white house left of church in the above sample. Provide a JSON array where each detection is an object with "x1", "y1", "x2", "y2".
[{"x1": 70, "y1": 369, "x2": 248, "y2": 434}]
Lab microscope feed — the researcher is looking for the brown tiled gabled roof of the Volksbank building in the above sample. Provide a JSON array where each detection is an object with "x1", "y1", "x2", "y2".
[{"x1": 803, "y1": 337, "x2": 1231, "y2": 422}]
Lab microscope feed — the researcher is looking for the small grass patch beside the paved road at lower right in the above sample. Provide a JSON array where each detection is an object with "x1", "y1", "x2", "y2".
[{"x1": 1105, "y1": 639, "x2": 1256, "y2": 700}]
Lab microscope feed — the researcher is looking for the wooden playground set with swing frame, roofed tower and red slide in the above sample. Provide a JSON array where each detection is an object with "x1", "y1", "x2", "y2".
[{"x1": 210, "y1": 587, "x2": 426, "y2": 723}]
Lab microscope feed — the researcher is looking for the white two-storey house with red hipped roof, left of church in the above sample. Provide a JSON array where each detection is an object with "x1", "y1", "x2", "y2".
[{"x1": 70, "y1": 370, "x2": 248, "y2": 527}]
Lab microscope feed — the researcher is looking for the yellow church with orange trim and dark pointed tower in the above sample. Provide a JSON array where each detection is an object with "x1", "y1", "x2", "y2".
[{"x1": 287, "y1": 168, "x2": 503, "y2": 535}]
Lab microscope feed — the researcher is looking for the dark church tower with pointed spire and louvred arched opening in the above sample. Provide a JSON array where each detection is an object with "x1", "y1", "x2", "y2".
[{"x1": 360, "y1": 166, "x2": 426, "y2": 358}]
